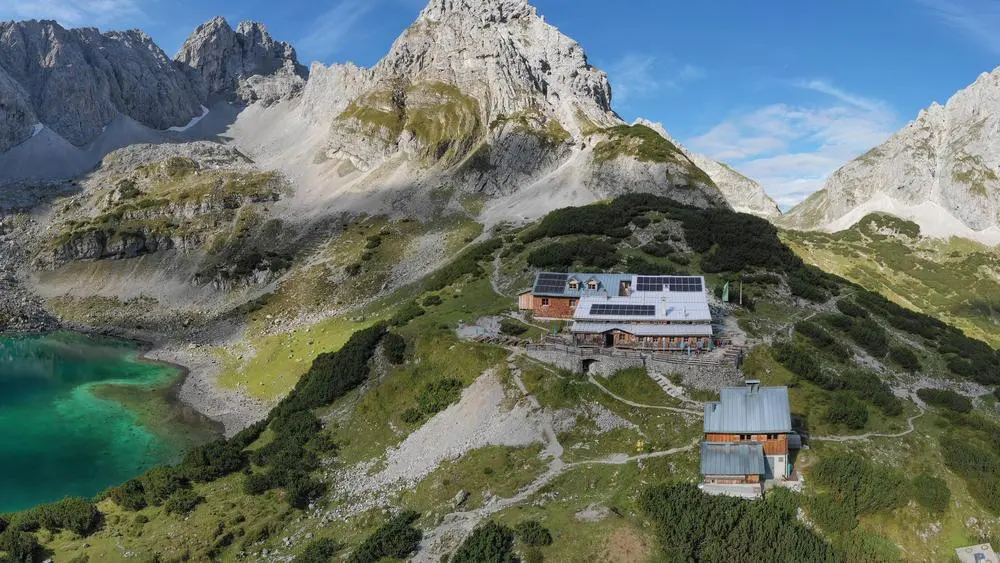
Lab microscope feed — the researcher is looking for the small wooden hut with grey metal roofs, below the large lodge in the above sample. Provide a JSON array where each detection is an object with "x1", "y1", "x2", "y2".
[{"x1": 701, "y1": 380, "x2": 801, "y2": 485}]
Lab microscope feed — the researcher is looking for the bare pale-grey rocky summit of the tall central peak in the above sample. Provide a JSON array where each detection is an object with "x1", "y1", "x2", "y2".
[{"x1": 364, "y1": 0, "x2": 620, "y2": 132}]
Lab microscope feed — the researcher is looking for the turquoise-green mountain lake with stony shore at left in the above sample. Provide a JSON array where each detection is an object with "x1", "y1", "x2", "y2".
[{"x1": 0, "y1": 333, "x2": 218, "y2": 513}]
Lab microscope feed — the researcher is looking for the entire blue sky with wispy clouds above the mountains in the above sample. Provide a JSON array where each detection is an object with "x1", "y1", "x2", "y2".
[{"x1": 0, "y1": 0, "x2": 1000, "y2": 207}]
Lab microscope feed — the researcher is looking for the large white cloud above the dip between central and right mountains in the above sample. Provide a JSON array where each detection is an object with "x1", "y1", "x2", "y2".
[{"x1": 688, "y1": 80, "x2": 898, "y2": 209}]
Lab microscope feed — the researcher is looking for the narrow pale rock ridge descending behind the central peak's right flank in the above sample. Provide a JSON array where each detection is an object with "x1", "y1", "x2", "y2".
[{"x1": 636, "y1": 118, "x2": 781, "y2": 220}]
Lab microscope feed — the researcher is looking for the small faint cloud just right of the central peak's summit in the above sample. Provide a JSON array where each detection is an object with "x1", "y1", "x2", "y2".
[{"x1": 608, "y1": 53, "x2": 706, "y2": 104}]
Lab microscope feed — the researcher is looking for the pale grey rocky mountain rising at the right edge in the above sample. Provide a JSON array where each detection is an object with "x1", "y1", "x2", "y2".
[{"x1": 784, "y1": 68, "x2": 1000, "y2": 243}]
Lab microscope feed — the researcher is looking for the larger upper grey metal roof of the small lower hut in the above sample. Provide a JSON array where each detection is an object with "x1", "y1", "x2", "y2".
[{"x1": 705, "y1": 386, "x2": 792, "y2": 434}]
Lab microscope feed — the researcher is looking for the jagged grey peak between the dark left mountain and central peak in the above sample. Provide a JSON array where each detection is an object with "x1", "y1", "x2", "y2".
[{"x1": 175, "y1": 17, "x2": 308, "y2": 104}]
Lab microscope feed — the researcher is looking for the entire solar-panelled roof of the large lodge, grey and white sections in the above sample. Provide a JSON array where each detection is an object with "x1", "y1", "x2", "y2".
[{"x1": 533, "y1": 272, "x2": 712, "y2": 323}]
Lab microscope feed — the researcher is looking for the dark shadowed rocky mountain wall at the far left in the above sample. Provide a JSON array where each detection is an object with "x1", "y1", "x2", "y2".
[{"x1": 0, "y1": 20, "x2": 201, "y2": 150}]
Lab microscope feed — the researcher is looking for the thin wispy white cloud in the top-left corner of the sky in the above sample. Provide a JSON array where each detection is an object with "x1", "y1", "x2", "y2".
[{"x1": 0, "y1": 0, "x2": 143, "y2": 27}]
